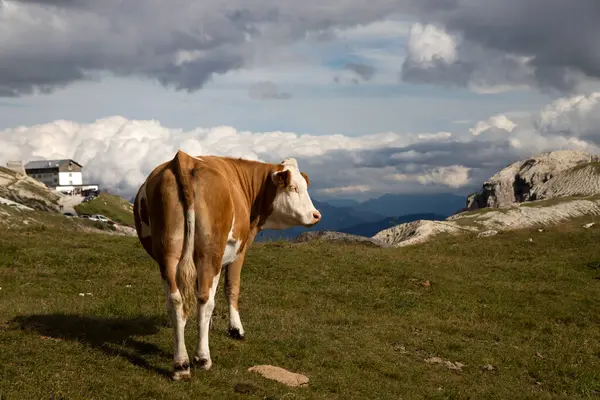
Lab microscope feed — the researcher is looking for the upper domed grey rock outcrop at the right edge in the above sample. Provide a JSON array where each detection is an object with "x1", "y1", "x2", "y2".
[{"x1": 466, "y1": 150, "x2": 600, "y2": 210}]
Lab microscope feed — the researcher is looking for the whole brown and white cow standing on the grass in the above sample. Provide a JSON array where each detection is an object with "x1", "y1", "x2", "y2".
[{"x1": 133, "y1": 150, "x2": 321, "y2": 380}]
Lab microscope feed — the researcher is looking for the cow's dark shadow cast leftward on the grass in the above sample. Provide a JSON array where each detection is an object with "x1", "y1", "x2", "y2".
[{"x1": 11, "y1": 314, "x2": 172, "y2": 377}]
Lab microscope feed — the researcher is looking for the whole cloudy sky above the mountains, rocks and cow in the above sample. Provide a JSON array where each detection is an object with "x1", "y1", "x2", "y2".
[{"x1": 0, "y1": 0, "x2": 600, "y2": 200}]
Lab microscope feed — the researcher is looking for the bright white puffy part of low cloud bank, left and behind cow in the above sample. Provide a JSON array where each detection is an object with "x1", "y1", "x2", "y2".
[{"x1": 0, "y1": 117, "x2": 454, "y2": 196}]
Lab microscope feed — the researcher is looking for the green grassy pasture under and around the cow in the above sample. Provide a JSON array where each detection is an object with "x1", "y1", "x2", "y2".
[{"x1": 0, "y1": 214, "x2": 600, "y2": 399}]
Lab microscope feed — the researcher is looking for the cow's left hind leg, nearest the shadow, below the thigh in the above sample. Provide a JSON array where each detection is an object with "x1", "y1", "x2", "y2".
[{"x1": 163, "y1": 258, "x2": 191, "y2": 381}]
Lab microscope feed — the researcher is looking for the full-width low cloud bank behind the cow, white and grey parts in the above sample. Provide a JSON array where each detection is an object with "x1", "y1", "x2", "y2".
[{"x1": 0, "y1": 93, "x2": 600, "y2": 198}]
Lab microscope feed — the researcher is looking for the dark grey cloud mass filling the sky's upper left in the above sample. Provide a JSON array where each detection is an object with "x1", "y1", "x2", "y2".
[{"x1": 0, "y1": 0, "x2": 428, "y2": 96}]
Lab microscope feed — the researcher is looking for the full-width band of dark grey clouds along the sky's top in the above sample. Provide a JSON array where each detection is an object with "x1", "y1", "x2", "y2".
[{"x1": 0, "y1": 0, "x2": 600, "y2": 96}]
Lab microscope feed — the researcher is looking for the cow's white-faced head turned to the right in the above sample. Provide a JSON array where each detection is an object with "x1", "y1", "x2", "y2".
[{"x1": 263, "y1": 158, "x2": 321, "y2": 229}]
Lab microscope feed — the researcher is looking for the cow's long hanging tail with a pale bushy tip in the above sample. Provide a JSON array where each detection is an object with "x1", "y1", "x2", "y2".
[{"x1": 174, "y1": 150, "x2": 197, "y2": 315}]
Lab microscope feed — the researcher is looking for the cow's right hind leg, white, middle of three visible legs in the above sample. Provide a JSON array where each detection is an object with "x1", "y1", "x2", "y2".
[{"x1": 194, "y1": 268, "x2": 221, "y2": 370}]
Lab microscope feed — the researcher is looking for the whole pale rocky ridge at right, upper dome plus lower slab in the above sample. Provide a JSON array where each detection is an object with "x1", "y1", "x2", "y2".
[{"x1": 373, "y1": 150, "x2": 600, "y2": 247}]
